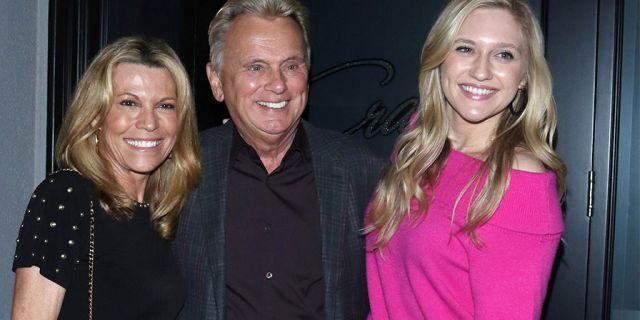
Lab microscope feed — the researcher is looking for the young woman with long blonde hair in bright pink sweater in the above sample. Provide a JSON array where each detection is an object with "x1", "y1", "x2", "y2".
[{"x1": 366, "y1": 0, "x2": 565, "y2": 320}]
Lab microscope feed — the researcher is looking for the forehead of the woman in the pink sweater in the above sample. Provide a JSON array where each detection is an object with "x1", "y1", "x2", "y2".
[{"x1": 457, "y1": 8, "x2": 526, "y2": 48}]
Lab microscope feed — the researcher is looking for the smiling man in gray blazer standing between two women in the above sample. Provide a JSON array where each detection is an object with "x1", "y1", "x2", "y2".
[{"x1": 175, "y1": 0, "x2": 382, "y2": 320}]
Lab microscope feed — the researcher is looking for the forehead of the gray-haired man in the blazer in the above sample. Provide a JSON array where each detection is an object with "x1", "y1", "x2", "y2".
[{"x1": 225, "y1": 15, "x2": 304, "y2": 56}]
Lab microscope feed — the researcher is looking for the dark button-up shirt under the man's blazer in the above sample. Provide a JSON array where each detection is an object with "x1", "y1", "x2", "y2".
[{"x1": 225, "y1": 125, "x2": 324, "y2": 320}]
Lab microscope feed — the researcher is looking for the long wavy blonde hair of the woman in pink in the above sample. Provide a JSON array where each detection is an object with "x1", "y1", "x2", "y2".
[{"x1": 365, "y1": 0, "x2": 566, "y2": 249}]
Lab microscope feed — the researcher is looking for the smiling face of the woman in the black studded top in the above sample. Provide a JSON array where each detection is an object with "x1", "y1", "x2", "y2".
[{"x1": 98, "y1": 63, "x2": 179, "y2": 190}]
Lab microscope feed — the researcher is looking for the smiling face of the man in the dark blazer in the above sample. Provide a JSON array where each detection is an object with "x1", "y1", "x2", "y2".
[{"x1": 207, "y1": 15, "x2": 308, "y2": 148}]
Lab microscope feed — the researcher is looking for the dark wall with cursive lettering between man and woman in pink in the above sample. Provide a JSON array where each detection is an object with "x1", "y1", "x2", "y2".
[{"x1": 306, "y1": 0, "x2": 446, "y2": 156}]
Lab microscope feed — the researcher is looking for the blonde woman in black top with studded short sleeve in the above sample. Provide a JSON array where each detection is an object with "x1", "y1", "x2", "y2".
[{"x1": 12, "y1": 37, "x2": 200, "y2": 319}]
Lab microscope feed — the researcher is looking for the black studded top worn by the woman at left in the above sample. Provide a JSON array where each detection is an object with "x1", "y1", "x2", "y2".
[{"x1": 13, "y1": 171, "x2": 185, "y2": 320}]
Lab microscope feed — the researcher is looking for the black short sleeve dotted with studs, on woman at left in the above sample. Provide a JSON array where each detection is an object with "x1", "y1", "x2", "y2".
[{"x1": 13, "y1": 170, "x2": 93, "y2": 288}]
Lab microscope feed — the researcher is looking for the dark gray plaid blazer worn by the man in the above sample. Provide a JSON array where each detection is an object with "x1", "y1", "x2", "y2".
[{"x1": 174, "y1": 122, "x2": 383, "y2": 320}]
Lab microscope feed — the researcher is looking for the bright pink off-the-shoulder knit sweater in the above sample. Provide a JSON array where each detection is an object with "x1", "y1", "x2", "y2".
[{"x1": 367, "y1": 150, "x2": 563, "y2": 320}]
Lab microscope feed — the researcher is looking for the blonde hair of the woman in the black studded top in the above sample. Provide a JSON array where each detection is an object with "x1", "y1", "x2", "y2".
[{"x1": 55, "y1": 37, "x2": 200, "y2": 239}]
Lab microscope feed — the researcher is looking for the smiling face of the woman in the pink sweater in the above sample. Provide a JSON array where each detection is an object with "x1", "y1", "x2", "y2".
[{"x1": 440, "y1": 8, "x2": 527, "y2": 131}]
